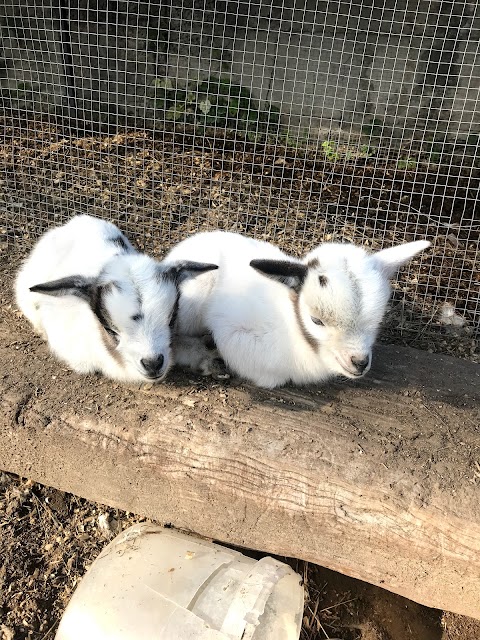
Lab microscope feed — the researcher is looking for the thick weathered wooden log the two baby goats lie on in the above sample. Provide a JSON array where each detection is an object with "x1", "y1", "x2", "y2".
[{"x1": 0, "y1": 264, "x2": 480, "y2": 618}]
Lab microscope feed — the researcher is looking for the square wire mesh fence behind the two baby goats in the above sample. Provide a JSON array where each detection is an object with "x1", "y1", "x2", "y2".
[{"x1": 0, "y1": 0, "x2": 480, "y2": 359}]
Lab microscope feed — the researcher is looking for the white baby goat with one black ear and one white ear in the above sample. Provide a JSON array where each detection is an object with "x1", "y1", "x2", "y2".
[{"x1": 165, "y1": 231, "x2": 430, "y2": 388}]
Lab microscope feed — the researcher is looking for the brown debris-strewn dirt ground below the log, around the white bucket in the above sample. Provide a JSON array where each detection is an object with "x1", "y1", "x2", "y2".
[{"x1": 0, "y1": 473, "x2": 480, "y2": 640}]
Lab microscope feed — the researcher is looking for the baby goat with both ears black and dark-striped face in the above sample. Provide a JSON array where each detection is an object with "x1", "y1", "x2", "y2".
[{"x1": 15, "y1": 215, "x2": 217, "y2": 382}]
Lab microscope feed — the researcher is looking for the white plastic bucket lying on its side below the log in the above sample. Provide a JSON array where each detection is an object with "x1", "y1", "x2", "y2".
[{"x1": 56, "y1": 524, "x2": 304, "y2": 640}]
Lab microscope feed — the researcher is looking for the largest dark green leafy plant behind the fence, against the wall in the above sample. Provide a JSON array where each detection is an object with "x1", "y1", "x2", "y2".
[{"x1": 151, "y1": 76, "x2": 280, "y2": 139}]
